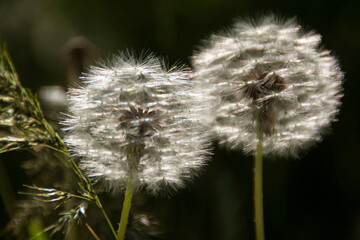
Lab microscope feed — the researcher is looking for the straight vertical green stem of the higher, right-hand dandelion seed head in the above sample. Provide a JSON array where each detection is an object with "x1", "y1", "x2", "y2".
[{"x1": 254, "y1": 111, "x2": 265, "y2": 240}]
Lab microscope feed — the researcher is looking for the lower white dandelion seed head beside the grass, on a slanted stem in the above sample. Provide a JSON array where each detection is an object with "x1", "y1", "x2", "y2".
[{"x1": 64, "y1": 54, "x2": 209, "y2": 193}]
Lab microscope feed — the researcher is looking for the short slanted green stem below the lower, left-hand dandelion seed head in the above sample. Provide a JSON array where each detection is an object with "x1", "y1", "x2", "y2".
[{"x1": 117, "y1": 174, "x2": 134, "y2": 240}]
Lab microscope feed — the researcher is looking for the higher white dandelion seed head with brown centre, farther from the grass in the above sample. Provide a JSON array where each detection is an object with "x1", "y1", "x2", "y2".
[{"x1": 192, "y1": 16, "x2": 343, "y2": 157}]
